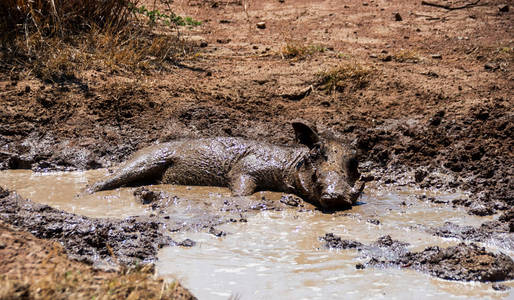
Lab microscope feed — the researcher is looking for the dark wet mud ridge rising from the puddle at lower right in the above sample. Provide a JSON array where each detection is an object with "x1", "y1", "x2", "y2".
[{"x1": 321, "y1": 233, "x2": 514, "y2": 282}]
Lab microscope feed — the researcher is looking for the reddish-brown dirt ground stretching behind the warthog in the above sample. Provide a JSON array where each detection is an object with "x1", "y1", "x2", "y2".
[{"x1": 0, "y1": 0, "x2": 514, "y2": 296}]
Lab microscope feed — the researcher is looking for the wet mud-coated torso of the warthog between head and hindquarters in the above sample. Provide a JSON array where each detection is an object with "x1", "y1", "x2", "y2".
[{"x1": 162, "y1": 137, "x2": 307, "y2": 186}]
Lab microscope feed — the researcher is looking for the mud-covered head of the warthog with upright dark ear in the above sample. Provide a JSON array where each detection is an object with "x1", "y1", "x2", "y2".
[{"x1": 292, "y1": 123, "x2": 364, "y2": 210}]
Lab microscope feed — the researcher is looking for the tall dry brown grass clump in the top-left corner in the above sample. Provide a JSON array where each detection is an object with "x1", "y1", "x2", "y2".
[{"x1": 0, "y1": 0, "x2": 192, "y2": 82}]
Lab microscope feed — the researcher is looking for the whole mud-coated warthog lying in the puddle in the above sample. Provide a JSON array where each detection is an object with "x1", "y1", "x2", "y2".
[{"x1": 88, "y1": 122, "x2": 364, "y2": 209}]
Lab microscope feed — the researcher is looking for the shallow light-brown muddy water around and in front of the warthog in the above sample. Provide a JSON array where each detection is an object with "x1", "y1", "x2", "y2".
[{"x1": 0, "y1": 170, "x2": 514, "y2": 299}]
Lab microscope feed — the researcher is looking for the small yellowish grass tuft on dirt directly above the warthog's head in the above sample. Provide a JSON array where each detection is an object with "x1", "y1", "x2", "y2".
[{"x1": 317, "y1": 63, "x2": 375, "y2": 92}]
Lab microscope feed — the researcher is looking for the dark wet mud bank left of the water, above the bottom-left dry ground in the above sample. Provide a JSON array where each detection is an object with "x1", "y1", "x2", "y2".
[{"x1": 0, "y1": 188, "x2": 175, "y2": 267}]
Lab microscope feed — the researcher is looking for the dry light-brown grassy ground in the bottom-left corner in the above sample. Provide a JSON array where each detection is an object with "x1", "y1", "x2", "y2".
[{"x1": 0, "y1": 222, "x2": 194, "y2": 300}]
